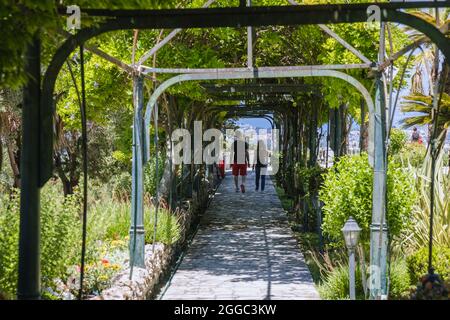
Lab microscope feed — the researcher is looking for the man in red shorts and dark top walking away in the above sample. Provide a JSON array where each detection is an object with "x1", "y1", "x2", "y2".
[{"x1": 231, "y1": 130, "x2": 250, "y2": 193}]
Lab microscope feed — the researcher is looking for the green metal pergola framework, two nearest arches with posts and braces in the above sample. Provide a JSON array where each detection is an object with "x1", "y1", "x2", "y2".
[{"x1": 18, "y1": 0, "x2": 450, "y2": 299}]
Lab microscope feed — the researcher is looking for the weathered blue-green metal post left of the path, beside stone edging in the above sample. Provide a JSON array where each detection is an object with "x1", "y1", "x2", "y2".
[{"x1": 130, "y1": 76, "x2": 148, "y2": 268}]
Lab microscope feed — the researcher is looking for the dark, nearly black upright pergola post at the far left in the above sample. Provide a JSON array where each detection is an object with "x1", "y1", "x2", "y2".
[{"x1": 17, "y1": 36, "x2": 41, "y2": 300}]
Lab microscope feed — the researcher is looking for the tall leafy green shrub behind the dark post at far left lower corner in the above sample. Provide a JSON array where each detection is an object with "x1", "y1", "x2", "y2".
[{"x1": 0, "y1": 182, "x2": 81, "y2": 298}]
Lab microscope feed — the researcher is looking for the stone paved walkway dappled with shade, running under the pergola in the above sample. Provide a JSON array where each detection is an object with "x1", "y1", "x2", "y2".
[{"x1": 159, "y1": 174, "x2": 319, "y2": 300}]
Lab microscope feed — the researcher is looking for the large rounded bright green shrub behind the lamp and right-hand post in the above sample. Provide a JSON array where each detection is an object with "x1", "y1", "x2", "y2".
[{"x1": 319, "y1": 154, "x2": 416, "y2": 242}]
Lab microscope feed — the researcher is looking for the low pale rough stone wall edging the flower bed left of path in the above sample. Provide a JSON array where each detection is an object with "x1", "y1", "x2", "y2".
[{"x1": 95, "y1": 243, "x2": 173, "y2": 300}]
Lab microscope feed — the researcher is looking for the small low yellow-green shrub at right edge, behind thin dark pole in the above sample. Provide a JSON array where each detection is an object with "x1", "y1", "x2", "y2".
[{"x1": 406, "y1": 247, "x2": 450, "y2": 285}]
